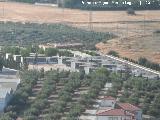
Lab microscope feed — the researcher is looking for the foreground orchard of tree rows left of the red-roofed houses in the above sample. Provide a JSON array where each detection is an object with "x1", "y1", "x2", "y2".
[{"x1": 1, "y1": 69, "x2": 109, "y2": 120}]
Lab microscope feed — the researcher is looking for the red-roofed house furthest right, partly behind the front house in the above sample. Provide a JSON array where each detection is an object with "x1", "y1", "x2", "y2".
[{"x1": 118, "y1": 103, "x2": 142, "y2": 120}]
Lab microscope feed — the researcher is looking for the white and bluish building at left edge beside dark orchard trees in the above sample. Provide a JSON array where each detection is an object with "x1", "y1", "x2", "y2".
[{"x1": 0, "y1": 88, "x2": 13, "y2": 113}]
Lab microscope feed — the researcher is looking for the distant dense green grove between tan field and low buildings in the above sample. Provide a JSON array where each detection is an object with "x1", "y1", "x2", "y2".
[{"x1": 0, "y1": 22, "x2": 113, "y2": 49}]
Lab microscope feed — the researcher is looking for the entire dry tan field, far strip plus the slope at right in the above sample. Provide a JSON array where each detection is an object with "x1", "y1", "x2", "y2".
[{"x1": 0, "y1": 2, "x2": 160, "y2": 63}]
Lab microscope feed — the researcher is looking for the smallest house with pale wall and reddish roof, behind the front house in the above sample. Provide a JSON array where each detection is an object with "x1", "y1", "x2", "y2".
[{"x1": 100, "y1": 96, "x2": 116, "y2": 108}]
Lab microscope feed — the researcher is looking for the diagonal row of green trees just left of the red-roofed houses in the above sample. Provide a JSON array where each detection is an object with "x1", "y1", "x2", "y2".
[{"x1": 66, "y1": 68, "x2": 110, "y2": 120}]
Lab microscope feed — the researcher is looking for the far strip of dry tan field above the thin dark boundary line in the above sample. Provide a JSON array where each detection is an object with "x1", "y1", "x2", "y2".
[{"x1": 0, "y1": 2, "x2": 160, "y2": 23}]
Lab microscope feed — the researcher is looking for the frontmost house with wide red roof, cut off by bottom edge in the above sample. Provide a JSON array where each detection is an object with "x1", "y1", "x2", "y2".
[{"x1": 96, "y1": 109, "x2": 134, "y2": 120}]
